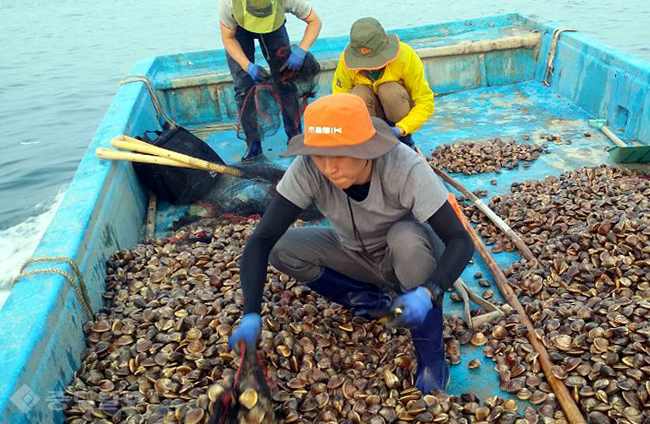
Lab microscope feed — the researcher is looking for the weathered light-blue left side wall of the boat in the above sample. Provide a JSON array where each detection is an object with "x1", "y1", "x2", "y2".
[{"x1": 0, "y1": 55, "x2": 163, "y2": 424}]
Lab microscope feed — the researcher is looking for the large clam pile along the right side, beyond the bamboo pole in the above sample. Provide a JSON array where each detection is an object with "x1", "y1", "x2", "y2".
[{"x1": 456, "y1": 166, "x2": 650, "y2": 424}]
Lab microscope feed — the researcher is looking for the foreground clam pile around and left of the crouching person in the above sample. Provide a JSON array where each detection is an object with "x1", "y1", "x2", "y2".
[{"x1": 65, "y1": 220, "x2": 544, "y2": 424}]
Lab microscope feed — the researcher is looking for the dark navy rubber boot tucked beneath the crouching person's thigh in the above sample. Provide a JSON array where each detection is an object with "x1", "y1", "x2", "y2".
[{"x1": 307, "y1": 268, "x2": 393, "y2": 319}]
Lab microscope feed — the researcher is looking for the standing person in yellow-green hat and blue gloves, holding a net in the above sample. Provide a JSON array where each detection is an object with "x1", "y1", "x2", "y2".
[{"x1": 219, "y1": 0, "x2": 322, "y2": 161}]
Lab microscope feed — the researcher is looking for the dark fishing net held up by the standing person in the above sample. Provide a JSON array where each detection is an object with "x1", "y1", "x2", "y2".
[{"x1": 237, "y1": 46, "x2": 320, "y2": 141}]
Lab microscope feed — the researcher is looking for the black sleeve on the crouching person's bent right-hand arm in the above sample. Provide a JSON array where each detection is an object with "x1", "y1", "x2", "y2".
[{"x1": 426, "y1": 202, "x2": 474, "y2": 292}]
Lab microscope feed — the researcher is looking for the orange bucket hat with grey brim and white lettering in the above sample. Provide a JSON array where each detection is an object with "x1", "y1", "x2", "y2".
[{"x1": 281, "y1": 93, "x2": 399, "y2": 159}]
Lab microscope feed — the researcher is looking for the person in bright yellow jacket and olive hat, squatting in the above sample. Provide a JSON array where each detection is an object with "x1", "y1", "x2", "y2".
[{"x1": 332, "y1": 18, "x2": 433, "y2": 147}]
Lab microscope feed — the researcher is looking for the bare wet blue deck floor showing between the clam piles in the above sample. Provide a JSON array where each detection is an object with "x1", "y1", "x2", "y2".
[{"x1": 159, "y1": 81, "x2": 644, "y2": 399}]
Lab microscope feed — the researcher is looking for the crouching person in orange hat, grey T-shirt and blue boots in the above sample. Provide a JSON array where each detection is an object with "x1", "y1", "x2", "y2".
[{"x1": 230, "y1": 94, "x2": 473, "y2": 393}]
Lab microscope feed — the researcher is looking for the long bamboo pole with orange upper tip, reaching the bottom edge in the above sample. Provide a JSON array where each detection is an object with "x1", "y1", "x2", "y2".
[{"x1": 454, "y1": 200, "x2": 587, "y2": 424}]
